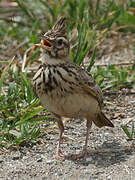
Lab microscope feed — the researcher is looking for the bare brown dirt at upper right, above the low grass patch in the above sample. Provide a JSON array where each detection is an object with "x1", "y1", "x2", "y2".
[{"x1": 85, "y1": 32, "x2": 135, "y2": 67}]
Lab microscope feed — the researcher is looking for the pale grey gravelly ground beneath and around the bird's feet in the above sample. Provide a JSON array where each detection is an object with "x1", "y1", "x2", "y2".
[{"x1": 0, "y1": 94, "x2": 135, "y2": 180}]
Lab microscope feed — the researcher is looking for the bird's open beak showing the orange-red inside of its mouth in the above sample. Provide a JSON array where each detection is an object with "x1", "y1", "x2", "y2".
[{"x1": 41, "y1": 35, "x2": 52, "y2": 51}]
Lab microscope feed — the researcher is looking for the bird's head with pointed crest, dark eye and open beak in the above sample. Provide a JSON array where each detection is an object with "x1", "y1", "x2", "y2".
[{"x1": 41, "y1": 17, "x2": 70, "y2": 59}]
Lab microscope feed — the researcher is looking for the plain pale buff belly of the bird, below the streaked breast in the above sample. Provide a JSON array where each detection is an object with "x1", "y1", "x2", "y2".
[{"x1": 40, "y1": 94, "x2": 100, "y2": 118}]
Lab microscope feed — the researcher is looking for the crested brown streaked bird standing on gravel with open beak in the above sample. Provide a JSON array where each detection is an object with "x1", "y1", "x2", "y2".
[{"x1": 33, "y1": 16, "x2": 114, "y2": 159}]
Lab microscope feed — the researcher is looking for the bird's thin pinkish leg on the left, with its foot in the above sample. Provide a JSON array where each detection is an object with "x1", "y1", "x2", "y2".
[{"x1": 56, "y1": 116, "x2": 65, "y2": 158}]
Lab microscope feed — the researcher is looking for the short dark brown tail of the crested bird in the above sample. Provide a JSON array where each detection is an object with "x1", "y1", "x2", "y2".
[{"x1": 94, "y1": 111, "x2": 114, "y2": 128}]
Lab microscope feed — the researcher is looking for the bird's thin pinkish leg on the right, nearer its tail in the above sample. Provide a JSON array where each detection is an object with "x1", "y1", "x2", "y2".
[{"x1": 72, "y1": 119, "x2": 92, "y2": 160}]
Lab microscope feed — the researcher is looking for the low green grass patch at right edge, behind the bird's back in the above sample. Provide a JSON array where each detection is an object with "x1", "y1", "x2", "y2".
[{"x1": 93, "y1": 63, "x2": 135, "y2": 92}]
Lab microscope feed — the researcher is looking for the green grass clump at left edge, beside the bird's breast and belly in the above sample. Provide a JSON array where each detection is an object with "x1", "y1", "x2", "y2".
[{"x1": 0, "y1": 59, "x2": 50, "y2": 147}]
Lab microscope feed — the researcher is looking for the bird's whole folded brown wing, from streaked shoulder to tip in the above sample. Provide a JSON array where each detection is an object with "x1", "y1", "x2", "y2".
[{"x1": 61, "y1": 62, "x2": 103, "y2": 106}]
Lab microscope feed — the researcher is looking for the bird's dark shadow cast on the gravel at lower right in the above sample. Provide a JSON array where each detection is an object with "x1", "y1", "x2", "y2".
[{"x1": 68, "y1": 141, "x2": 135, "y2": 167}]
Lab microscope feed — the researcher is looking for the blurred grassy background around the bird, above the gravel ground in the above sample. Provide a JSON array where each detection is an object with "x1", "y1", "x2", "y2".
[{"x1": 0, "y1": 0, "x2": 135, "y2": 149}]
